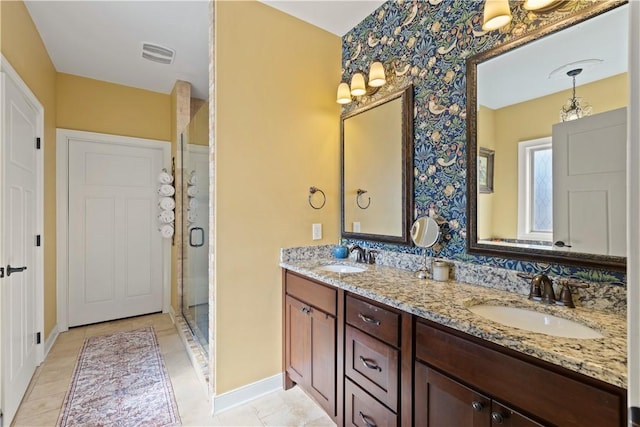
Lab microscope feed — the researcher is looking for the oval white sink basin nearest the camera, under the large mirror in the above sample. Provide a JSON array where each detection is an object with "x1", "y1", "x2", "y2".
[{"x1": 469, "y1": 304, "x2": 604, "y2": 339}]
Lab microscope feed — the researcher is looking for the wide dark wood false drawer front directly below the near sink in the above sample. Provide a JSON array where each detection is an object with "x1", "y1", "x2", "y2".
[{"x1": 416, "y1": 321, "x2": 626, "y2": 427}]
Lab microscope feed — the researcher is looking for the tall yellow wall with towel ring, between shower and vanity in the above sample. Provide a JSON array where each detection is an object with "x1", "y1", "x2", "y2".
[{"x1": 213, "y1": 1, "x2": 341, "y2": 393}]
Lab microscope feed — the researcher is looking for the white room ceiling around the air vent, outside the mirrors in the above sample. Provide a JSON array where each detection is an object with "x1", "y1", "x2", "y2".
[{"x1": 25, "y1": 0, "x2": 384, "y2": 99}]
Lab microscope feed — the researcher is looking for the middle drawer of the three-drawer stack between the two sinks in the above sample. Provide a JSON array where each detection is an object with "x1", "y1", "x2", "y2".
[{"x1": 344, "y1": 325, "x2": 399, "y2": 412}]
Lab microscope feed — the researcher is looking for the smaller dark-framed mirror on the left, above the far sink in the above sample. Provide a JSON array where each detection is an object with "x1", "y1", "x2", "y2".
[{"x1": 340, "y1": 85, "x2": 413, "y2": 245}]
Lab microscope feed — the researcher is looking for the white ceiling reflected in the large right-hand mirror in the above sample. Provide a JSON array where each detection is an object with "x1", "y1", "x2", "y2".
[{"x1": 478, "y1": 6, "x2": 629, "y2": 109}]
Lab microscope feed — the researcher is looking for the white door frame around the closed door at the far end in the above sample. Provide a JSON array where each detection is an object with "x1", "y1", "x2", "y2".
[{"x1": 56, "y1": 128, "x2": 171, "y2": 332}]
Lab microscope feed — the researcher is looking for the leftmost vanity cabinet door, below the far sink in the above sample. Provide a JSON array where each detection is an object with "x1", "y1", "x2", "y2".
[{"x1": 285, "y1": 295, "x2": 311, "y2": 384}]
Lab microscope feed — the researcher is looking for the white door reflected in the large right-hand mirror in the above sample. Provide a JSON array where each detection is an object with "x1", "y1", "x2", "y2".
[{"x1": 553, "y1": 108, "x2": 627, "y2": 256}]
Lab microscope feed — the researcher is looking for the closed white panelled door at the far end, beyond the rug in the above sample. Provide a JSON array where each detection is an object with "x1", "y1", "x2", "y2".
[{"x1": 68, "y1": 138, "x2": 163, "y2": 326}]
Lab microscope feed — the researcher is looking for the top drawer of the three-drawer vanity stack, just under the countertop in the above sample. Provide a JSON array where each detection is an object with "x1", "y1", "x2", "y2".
[{"x1": 346, "y1": 295, "x2": 400, "y2": 347}]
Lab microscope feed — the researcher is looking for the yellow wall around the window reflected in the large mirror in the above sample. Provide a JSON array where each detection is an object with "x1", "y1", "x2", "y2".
[{"x1": 478, "y1": 73, "x2": 629, "y2": 238}]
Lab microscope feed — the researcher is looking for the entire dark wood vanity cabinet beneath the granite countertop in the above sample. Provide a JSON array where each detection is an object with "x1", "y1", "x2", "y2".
[{"x1": 283, "y1": 270, "x2": 627, "y2": 427}]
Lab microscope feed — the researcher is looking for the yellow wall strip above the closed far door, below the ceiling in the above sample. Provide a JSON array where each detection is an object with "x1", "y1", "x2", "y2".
[{"x1": 56, "y1": 73, "x2": 171, "y2": 141}]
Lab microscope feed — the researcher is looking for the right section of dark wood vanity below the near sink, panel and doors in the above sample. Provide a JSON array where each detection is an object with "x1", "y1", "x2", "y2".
[{"x1": 414, "y1": 320, "x2": 626, "y2": 427}]
